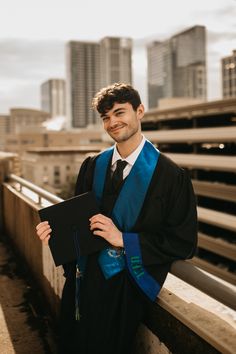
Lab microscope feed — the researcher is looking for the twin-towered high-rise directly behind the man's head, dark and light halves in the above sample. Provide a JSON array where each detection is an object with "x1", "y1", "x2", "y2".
[{"x1": 66, "y1": 37, "x2": 132, "y2": 128}]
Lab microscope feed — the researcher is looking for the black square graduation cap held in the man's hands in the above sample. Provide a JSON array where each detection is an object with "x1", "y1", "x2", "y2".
[{"x1": 39, "y1": 192, "x2": 109, "y2": 266}]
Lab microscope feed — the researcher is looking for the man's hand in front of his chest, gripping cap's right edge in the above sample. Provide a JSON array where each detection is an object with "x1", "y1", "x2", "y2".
[{"x1": 89, "y1": 214, "x2": 124, "y2": 247}]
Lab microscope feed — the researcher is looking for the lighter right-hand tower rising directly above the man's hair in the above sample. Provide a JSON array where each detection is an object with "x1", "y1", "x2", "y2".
[{"x1": 100, "y1": 37, "x2": 132, "y2": 87}]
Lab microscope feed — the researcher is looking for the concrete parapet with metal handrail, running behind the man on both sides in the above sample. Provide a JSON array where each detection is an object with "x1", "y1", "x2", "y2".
[{"x1": 2, "y1": 171, "x2": 236, "y2": 354}]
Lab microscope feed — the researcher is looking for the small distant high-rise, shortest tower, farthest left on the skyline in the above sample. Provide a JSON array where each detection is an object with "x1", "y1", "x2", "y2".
[{"x1": 41, "y1": 79, "x2": 66, "y2": 117}]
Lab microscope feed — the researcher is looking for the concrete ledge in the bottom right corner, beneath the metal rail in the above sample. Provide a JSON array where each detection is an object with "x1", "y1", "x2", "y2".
[{"x1": 137, "y1": 289, "x2": 236, "y2": 354}]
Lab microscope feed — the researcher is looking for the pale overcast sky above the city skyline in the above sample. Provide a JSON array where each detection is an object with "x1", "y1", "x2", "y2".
[{"x1": 0, "y1": 0, "x2": 236, "y2": 114}]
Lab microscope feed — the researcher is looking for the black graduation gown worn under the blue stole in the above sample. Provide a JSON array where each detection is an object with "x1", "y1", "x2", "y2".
[{"x1": 59, "y1": 154, "x2": 197, "y2": 354}]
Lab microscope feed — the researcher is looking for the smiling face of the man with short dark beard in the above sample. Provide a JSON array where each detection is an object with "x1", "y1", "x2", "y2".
[{"x1": 101, "y1": 102, "x2": 144, "y2": 143}]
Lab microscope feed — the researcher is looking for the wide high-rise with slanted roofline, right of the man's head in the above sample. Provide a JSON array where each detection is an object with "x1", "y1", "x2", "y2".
[{"x1": 147, "y1": 26, "x2": 206, "y2": 108}]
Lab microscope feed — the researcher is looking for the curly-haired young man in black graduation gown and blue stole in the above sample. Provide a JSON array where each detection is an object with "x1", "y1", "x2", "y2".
[{"x1": 37, "y1": 83, "x2": 197, "y2": 354}]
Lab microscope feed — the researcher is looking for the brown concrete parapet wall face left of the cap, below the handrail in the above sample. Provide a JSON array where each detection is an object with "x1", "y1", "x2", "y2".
[{"x1": 3, "y1": 185, "x2": 64, "y2": 315}]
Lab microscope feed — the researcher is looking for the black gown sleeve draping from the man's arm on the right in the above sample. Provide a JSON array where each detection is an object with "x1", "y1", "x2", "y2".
[{"x1": 123, "y1": 169, "x2": 197, "y2": 266}]
